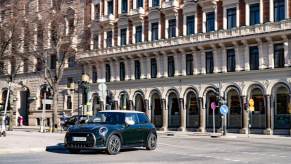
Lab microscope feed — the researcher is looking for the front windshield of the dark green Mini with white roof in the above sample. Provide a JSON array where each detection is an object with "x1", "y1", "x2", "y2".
[{"x1": 87, "y1": 112, "x2": 124, "y2": 124}]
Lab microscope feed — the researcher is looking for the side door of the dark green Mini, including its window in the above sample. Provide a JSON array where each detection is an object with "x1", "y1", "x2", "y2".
[{"x1": 122, "y1": 113, "x2": 140, "y2": 145}]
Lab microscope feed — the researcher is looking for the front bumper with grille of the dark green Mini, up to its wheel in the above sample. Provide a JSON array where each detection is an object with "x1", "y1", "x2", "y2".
[{"x1": 64, "y1": 132, "x2": 106, "y2": 149}]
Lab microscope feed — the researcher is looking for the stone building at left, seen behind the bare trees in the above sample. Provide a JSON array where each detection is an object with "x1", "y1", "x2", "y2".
[{"x1": 0, "y1": 0, "x2": 86, "y2": 126}]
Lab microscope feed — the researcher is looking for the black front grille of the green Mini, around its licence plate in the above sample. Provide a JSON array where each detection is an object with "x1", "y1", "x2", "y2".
[{"x1": 66, "y1": 133, "x2": 96, "y2": 149}]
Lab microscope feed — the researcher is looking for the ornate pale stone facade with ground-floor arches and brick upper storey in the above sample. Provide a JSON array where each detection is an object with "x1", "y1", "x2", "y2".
[{"x1": 78, "y1": 0, "x2": 291, "y2": 134}]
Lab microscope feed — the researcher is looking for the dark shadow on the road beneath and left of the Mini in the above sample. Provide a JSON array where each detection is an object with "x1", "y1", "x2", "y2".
[{"x1": 46, "y1": 143, "x2": 145, "y2": 155}]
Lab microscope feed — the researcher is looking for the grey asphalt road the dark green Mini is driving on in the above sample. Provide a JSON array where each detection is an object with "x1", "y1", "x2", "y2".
[{"x1": 0, "y1": 136, "x2": 291, "y2": 164}]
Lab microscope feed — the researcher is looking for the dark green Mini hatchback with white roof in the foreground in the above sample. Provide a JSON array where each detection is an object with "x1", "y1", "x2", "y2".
[{"x1": 64, "y1": 110, "x2": 157, "y2": 155}]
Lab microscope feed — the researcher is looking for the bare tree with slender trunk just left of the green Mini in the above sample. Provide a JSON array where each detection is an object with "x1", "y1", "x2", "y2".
[{"x1": 31, "y1": 0, "x2": 83, "y2": 132}]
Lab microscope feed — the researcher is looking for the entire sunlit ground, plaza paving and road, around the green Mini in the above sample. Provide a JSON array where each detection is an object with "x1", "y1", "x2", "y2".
[{"x1": 0, "y1": 132, "x2": 291, "y2": 164}]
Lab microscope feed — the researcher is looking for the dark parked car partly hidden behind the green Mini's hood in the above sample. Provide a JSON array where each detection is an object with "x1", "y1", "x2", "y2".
[{"x1": 61, "y1": 115, "x2": 89, "y2": 131}]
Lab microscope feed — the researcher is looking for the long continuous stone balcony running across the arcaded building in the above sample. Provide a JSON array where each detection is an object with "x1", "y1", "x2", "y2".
[{"x1": 77, "y1": 20, "x2": 291, "y2": 60}]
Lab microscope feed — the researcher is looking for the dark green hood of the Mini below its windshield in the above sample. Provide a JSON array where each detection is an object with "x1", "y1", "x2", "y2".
[{"x1": 69, "y1": 124, "x2": 122, "y2": 133}]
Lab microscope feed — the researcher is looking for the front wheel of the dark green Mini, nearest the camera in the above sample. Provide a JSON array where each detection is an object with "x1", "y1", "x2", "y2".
[{"x1": 106, "y1": 135, "x2": 121, "y2": 155}]
